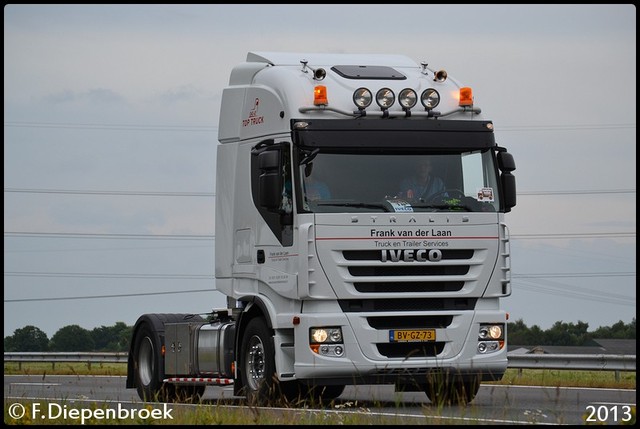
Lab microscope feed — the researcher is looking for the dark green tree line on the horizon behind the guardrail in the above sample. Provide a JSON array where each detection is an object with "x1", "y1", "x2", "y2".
[{"x1": 4, "y1": 317, "x2": 636, "y2": 352}]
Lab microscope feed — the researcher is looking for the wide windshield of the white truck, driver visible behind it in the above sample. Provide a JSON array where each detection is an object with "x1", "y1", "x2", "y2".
[{"x1": 298, "y1": 150, "x2": 500, "y2": 213}]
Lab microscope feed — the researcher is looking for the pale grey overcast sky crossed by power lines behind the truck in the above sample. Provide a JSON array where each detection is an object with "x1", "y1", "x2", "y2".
[{"x1": 4, "y1": 4, "x2": 636, "y2": 338}]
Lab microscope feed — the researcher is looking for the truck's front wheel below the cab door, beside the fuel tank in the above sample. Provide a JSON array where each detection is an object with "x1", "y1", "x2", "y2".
[{"x1": 240, "y1": 317, "x2": 280, "y2": 406}]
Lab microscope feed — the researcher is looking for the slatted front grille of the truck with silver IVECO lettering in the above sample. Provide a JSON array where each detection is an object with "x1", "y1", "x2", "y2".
[{"x1": 324, "y1": 242, "x2": 487, "y2": 362}]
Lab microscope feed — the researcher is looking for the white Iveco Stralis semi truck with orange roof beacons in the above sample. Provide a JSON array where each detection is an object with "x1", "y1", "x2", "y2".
[{"x1": 126, "y1": 52, "x2": 516, "y2": 404}]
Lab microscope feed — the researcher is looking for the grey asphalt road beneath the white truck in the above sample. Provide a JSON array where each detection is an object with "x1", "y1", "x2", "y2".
[{"x1": 4, "y1": 375, "x2": 636, "y2": 425}]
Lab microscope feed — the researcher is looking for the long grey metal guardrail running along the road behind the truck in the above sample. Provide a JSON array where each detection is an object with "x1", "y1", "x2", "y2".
[{"x1": 4, "y1": 352, "x2": 636, "y2": 371}]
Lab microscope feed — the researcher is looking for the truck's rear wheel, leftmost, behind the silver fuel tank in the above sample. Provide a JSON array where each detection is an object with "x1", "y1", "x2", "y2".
[{"x1": 133, "y1": 323, "x2": 175, "y2": 402}]
